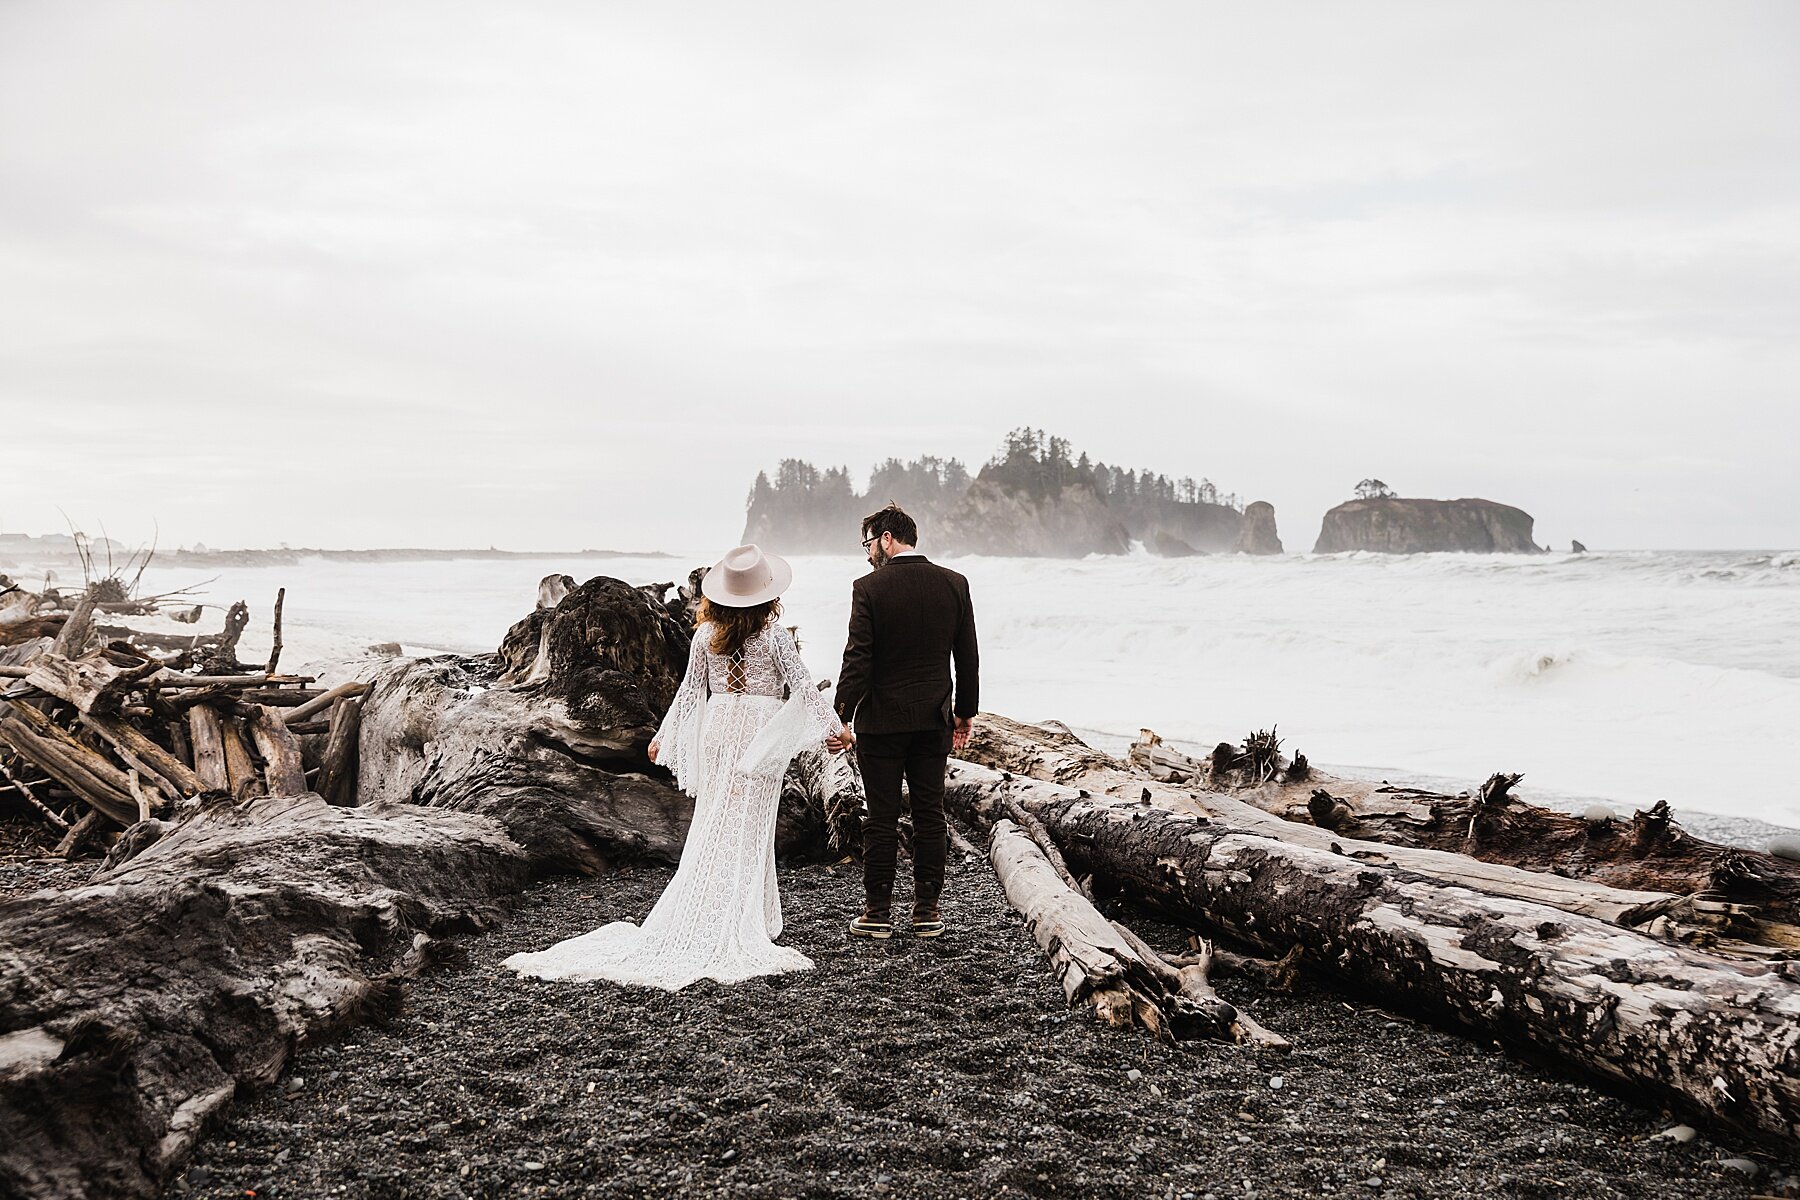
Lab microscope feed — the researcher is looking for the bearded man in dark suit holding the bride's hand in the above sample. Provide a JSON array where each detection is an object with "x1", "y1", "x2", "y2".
[{"x1": 830, "y1": 504, "x2": 977, "y2": 939}]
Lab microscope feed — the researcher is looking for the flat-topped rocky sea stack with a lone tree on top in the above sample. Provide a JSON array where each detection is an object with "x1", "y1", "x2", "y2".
[{"x1": 1312, "y1": 497, "x2": 1543, "y2": 554}]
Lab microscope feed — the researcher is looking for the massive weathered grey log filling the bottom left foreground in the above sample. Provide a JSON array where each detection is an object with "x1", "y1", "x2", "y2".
[{"x1": 0, "y1": 795, "x2": 531, "y2": 1200}]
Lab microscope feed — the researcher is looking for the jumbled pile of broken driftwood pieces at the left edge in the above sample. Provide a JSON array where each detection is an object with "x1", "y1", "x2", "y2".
[{"x1": 0, "y1": 581, "x2": 367, "y2": 856}]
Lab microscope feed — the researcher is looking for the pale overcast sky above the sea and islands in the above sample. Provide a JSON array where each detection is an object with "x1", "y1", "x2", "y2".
[{"x1": 0, "y1": 0, "x2": 1800, "y2": 551}]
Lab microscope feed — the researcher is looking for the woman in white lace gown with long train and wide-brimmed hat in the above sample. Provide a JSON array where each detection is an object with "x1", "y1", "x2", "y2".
[{"x1": 504, "y1": 545, "x2": 842, "y2": 991}]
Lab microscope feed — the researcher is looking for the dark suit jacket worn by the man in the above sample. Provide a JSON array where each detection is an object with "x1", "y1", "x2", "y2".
[{"x1": 837, "y1": 554, "x2": 981, "y2": 734}]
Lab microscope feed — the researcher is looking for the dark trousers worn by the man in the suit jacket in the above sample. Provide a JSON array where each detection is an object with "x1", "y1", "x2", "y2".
[{"x1": 857, "y1": 729, "x2": 950, "y2": 912}]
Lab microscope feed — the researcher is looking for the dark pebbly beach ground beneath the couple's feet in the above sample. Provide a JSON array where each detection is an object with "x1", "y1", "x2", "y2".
[{"x1": 0, "y1": 826, "x2": 1749, "y2": 1200}]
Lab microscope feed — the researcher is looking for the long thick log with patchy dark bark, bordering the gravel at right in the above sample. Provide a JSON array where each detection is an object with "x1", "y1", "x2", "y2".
[{"x1": 947, "y1": 763, "x2": 1800, "y2": 1144}]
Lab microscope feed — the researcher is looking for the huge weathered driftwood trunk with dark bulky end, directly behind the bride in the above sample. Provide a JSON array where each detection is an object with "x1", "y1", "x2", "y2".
[{"x1": 358, "y1": 578, "x2": 860, "y2": 873}]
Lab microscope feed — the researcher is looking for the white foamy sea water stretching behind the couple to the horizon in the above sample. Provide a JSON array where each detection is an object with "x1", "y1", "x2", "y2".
[{"x1": 84, "y1": 547, "x2": 1800, "y2": 826}]
